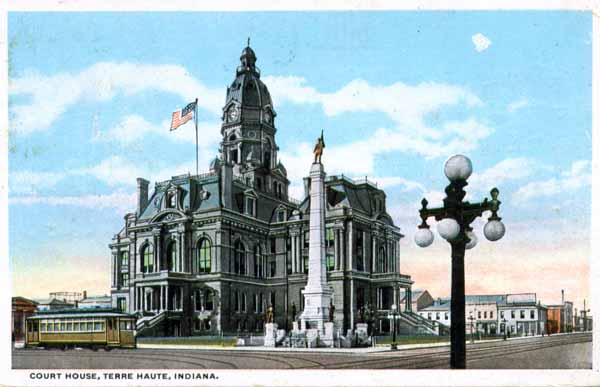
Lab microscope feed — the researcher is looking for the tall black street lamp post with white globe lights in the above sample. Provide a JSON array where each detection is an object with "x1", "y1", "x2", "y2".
[{"x1": 415, "y1": 155, "x2": 505, "y2": 368}]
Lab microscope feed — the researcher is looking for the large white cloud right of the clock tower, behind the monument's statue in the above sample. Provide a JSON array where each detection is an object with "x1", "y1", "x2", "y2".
[{"x1": 264, "y1": 76, "x2": 493, "y2": 164}]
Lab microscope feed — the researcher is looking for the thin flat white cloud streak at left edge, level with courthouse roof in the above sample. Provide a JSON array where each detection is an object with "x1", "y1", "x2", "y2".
[{"x1": 9, "y1": 191, "x2": 136, "y2": 213}]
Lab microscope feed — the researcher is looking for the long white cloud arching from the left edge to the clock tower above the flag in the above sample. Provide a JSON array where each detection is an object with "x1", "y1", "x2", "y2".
[{"x1": 9, "y1": 62, "x2": 223, "y2": 134}]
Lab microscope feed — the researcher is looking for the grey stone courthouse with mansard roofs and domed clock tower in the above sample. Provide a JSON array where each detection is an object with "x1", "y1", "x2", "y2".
[{"x1": 110, "y1": 47, "x2": 415, "y2": 336}]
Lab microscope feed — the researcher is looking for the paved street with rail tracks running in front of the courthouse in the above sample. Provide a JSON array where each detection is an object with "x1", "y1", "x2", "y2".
[{"x1": 12, "y1": 333, "x2": 592, "y2": 369}]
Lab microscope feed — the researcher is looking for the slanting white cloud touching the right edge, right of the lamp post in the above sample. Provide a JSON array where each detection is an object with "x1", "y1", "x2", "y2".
[{"x1": 512, "y1": 160, "x2": 592, "y2": 204}]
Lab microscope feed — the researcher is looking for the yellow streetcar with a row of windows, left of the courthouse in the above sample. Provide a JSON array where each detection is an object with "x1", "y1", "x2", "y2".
[{"x1": 25, "y1": 308, "x2": 136, "y2": 350}]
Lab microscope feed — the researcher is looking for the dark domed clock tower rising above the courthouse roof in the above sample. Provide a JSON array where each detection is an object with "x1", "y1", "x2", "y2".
[{"x1": 221, "y1": 46, "x2": 289, "y2": 199}]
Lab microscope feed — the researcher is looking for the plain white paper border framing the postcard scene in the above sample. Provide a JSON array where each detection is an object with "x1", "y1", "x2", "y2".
[{"x1": 0, "y1": 0, "x2": 600, "y2": 386}]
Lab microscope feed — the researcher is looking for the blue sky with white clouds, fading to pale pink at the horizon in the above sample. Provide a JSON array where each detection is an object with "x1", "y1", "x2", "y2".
[{"x1": 8, "y1": 11, "x2": 592, "y2": 308}]
